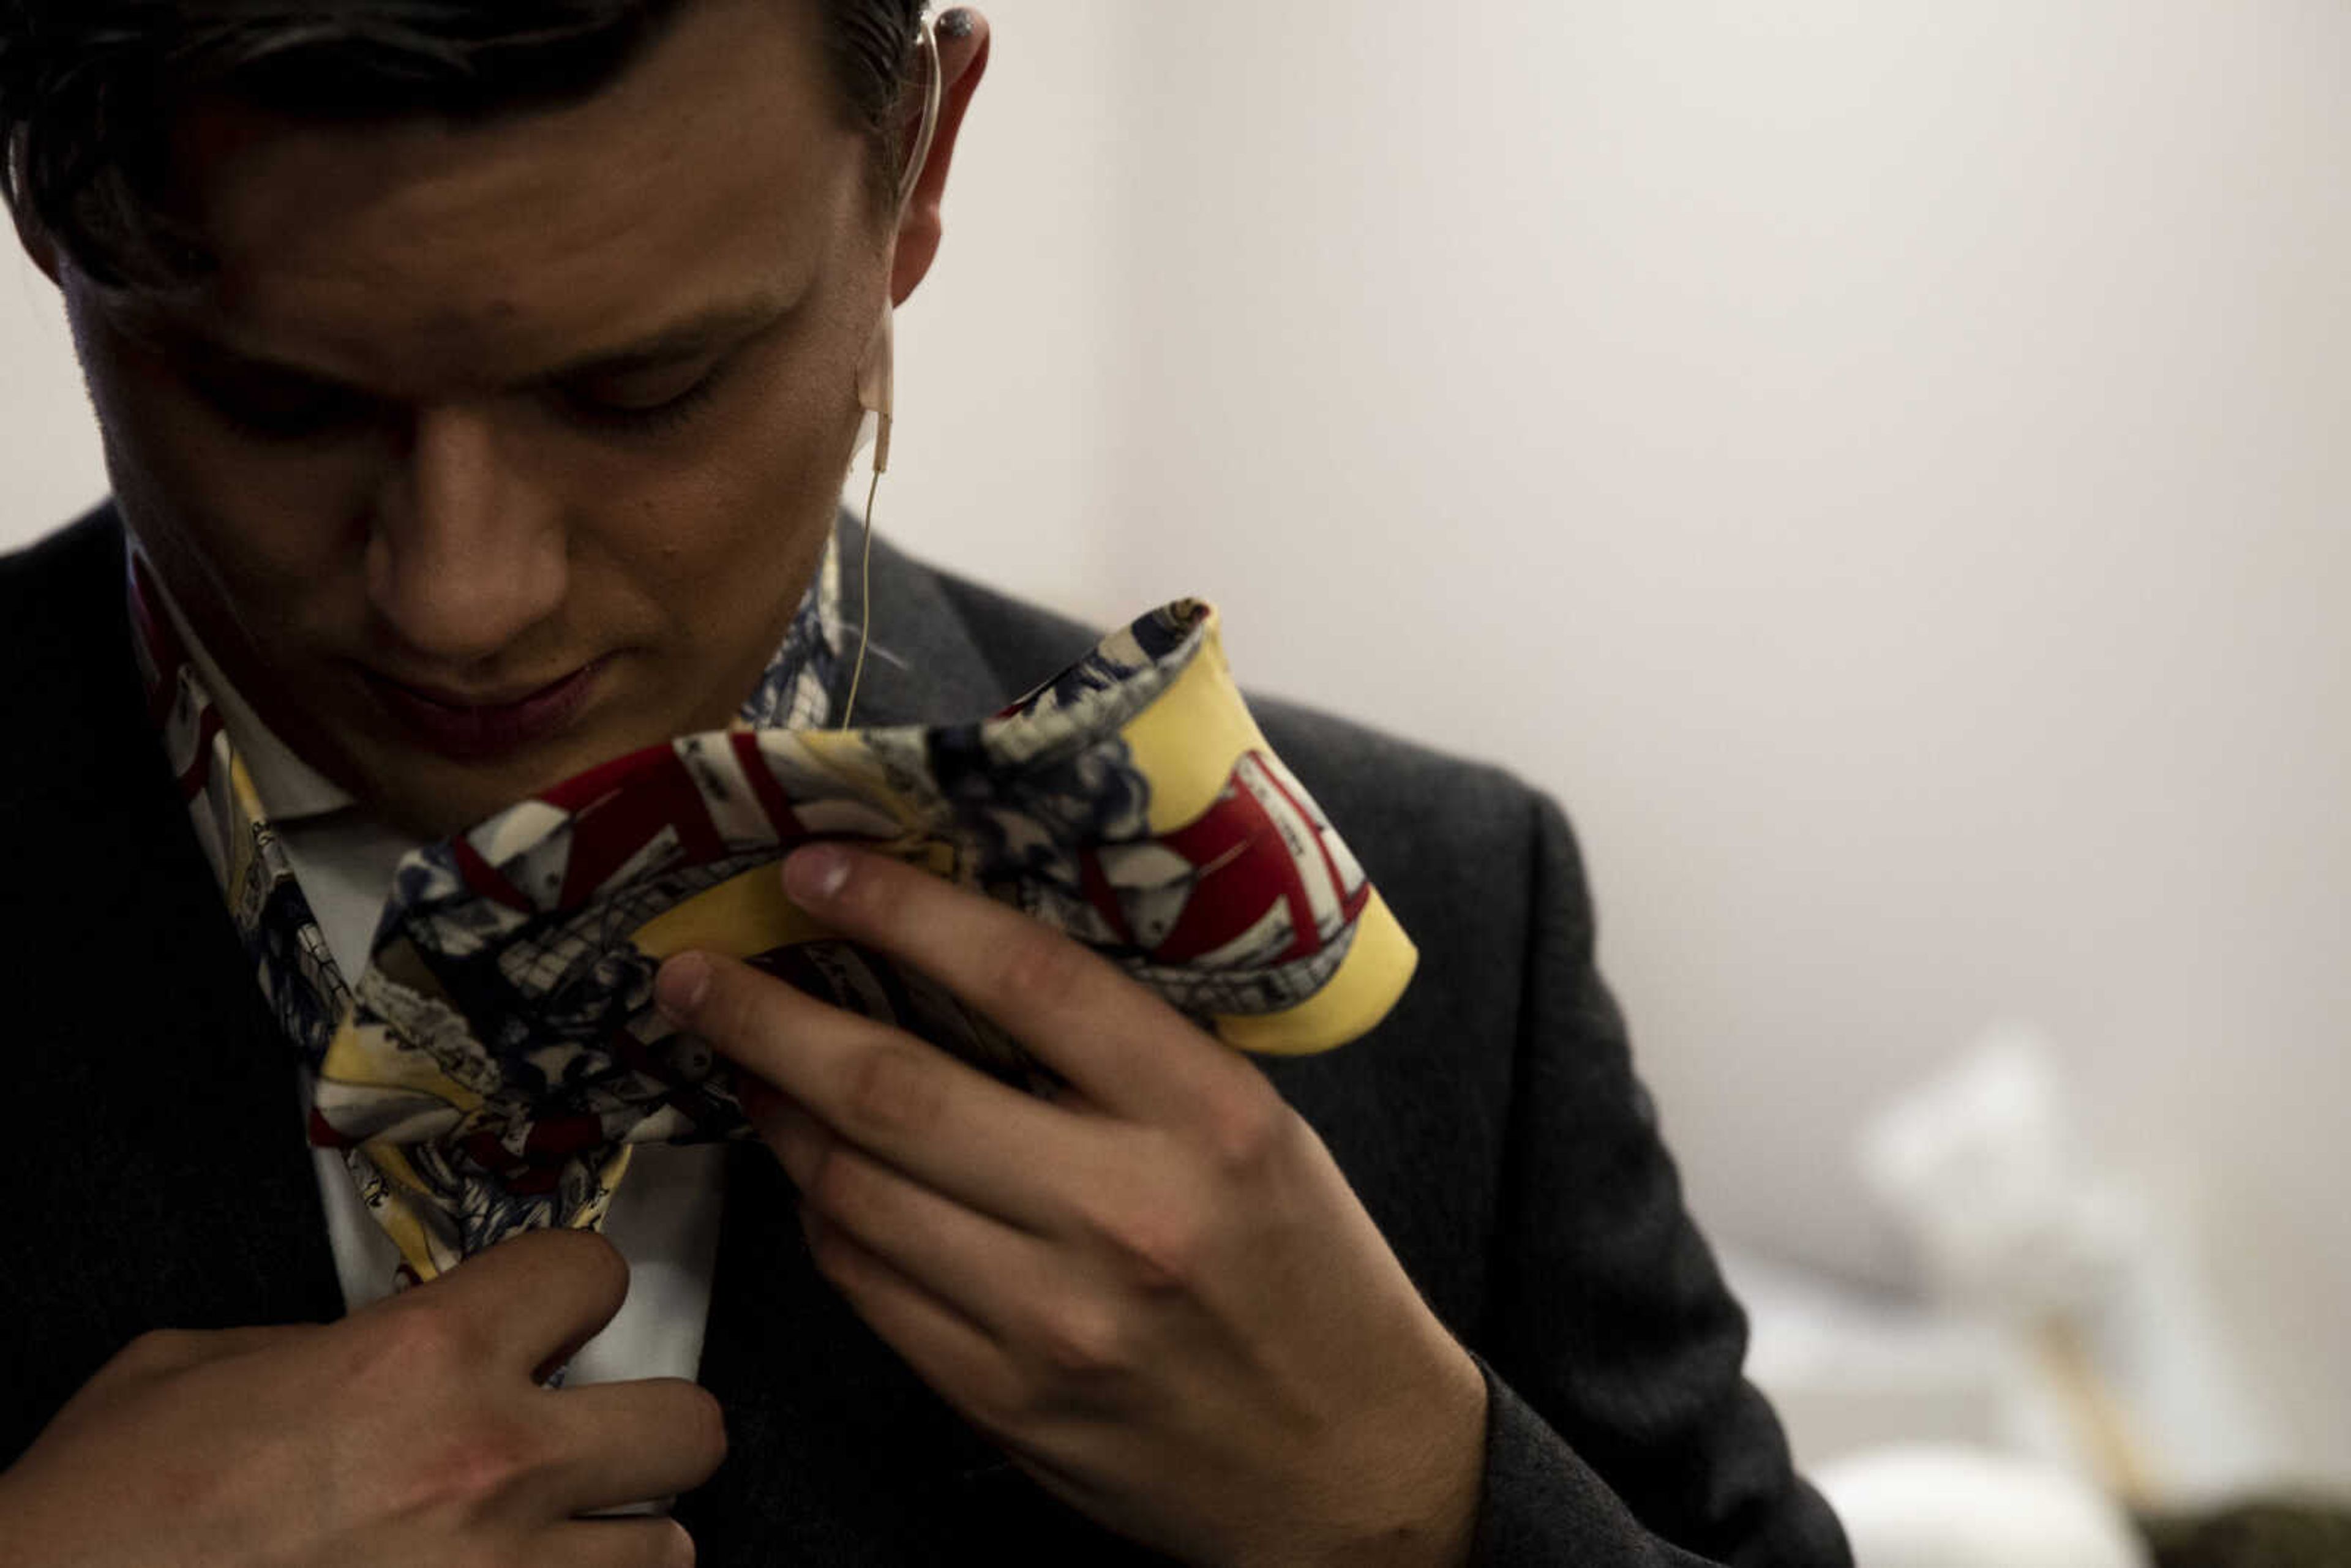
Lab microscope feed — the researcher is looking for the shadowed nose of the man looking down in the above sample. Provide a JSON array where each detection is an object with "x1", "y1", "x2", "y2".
[{"x1": 367, "y1": 409, "x2": 569, "y2": 666}]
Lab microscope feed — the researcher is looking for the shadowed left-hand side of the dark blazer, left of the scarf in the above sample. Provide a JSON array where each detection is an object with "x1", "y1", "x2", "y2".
[{"x1": 0, "y1": 512, "x2": 341, "y2": 1453}]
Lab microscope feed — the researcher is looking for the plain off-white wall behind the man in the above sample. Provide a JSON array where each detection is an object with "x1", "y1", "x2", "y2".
[{"x1": 0, "y1": 0, "x2": 2351, "y2": 1481}]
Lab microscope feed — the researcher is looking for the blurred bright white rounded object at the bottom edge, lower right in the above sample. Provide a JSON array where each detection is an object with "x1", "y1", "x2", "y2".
[{"x1": 1813, "y1": 1444, "x2": 2151, "y2": 1568}]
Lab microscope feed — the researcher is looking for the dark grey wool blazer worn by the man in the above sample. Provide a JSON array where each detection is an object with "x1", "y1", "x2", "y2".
[{"x1": 0, "y1": 508, "x2": 1850, "y2": 1568}]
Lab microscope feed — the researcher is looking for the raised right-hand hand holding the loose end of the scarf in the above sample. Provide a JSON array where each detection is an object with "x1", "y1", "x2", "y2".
[{"x1": 658, "y1": 846, "x2": 1486, "y2": 1566}]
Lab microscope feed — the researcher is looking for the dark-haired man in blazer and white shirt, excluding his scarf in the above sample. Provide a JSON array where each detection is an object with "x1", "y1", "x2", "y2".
[{"x1": 0, "y1": 0, "x2": 1843, "y2": 1566}]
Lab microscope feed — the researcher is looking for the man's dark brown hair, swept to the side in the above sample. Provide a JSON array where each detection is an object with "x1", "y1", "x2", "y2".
[{"x1": 0, "y1": 0, "x2": 921, "y2": 289}]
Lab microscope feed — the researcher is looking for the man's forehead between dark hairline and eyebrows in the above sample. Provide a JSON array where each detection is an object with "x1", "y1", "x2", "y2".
[{"x1": 137, "y1": 0, "x2": 870, "y2": 388}]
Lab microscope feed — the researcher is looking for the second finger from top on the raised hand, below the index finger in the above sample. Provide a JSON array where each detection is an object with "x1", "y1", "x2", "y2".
[{"x1": 661, "y1": 955, "x2": 1112, "y2": 1232}]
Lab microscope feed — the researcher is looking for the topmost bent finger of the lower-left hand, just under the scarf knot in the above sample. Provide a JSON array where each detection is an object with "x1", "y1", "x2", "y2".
[{"x1": 404, "y1": 1229, "x2": 628, "y2": 1378}]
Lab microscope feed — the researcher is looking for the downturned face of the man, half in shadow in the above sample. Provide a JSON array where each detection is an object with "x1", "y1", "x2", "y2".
[{"x1": 20, "y1": 0, "x2": 954, "y2": 835}]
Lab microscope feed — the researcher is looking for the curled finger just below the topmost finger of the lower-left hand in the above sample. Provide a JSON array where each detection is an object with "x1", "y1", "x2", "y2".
[{"x1": 550, "y1": 1378, "x2": 727, "y2": 1514}]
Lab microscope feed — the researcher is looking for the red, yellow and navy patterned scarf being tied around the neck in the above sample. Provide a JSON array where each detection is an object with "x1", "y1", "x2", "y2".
[{"x1": 132, "y1": 533, "x2": 1415, "y2": 1283}]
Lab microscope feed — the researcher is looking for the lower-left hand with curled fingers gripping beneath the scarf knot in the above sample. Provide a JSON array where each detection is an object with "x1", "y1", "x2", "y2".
[{"x1": 0, "y1": 1232, "x2": 727, "y2": 1568}]
